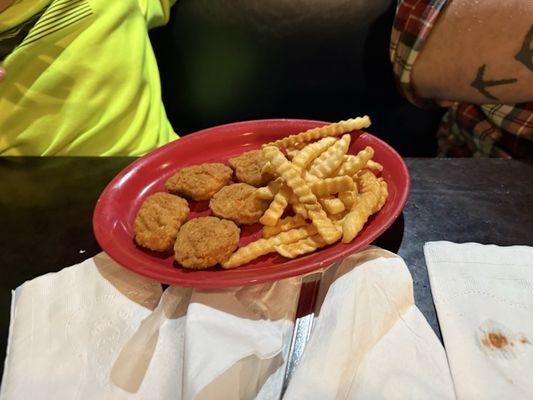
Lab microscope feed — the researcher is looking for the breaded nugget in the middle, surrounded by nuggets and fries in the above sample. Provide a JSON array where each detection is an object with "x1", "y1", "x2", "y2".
[{"x1": 209, "y1": 183, "x2": 268, "y2": 225}]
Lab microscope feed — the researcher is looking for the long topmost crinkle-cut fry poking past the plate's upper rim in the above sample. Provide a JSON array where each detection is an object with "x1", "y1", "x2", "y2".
[{"x1": 263, "y1": 115, "x2": 370, "y2": 148}]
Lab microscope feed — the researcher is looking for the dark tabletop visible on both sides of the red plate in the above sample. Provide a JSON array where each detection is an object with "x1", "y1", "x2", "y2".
[{"x1": 0, "y1": 157, "x2": 533, "y2": 378}]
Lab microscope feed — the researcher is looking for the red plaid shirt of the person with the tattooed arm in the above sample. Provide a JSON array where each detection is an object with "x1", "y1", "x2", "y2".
[{"x1": 390, "y1": 0, "x2": 533, "y2": 158}]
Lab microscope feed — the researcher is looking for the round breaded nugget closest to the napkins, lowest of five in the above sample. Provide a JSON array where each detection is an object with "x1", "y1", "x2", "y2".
[{"x1": 174, "y1": 217, "x2": 240, "y2": 269}]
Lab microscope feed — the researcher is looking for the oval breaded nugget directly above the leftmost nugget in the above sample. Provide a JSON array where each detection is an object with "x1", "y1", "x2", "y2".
[{"x1": 165, "y1": 163, "x2": 233, "y2": 201}]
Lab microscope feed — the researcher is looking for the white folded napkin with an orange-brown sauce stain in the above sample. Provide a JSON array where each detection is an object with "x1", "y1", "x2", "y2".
[{"x1": 424, "y1": 242, "x2": 533, "y2": 400}]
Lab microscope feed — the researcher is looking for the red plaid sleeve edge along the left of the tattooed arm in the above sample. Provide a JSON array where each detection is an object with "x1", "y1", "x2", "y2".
[{"x1": 390, "y1": 0, "x2": 448, "y2": 106}]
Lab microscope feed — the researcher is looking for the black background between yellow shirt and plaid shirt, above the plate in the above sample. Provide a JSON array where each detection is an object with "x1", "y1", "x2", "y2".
[{"x1": 150, "y1": 0, "x2": 443, "y2": 157}]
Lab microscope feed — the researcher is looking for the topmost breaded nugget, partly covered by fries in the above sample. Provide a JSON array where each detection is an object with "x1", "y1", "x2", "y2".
[{"x1": 229, "y1": 150, "x2": 274, "y2": 187}]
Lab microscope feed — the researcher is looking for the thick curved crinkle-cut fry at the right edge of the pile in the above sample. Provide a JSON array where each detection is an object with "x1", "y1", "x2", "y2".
[{"x1": 342, "y1": 170, "x2": 386, "y2": 243}]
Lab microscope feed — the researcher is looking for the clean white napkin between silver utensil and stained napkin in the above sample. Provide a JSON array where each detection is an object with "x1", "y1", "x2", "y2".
[{"x1": 285, "y1": 247, "x2": 454, "y2": 400}]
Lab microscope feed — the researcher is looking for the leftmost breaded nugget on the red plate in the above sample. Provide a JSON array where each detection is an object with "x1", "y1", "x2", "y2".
[{"x1": 133, "y1": 193, "x2": 189, "y2": 251}]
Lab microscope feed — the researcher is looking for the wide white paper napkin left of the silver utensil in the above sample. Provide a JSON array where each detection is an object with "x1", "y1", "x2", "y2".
[{"x1": 0, "y1": 253, "x2": 300, "y2": 400}]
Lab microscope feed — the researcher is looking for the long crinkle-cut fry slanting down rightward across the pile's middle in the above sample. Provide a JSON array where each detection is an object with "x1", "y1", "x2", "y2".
[{"x1": 263, "y1": 146, "x2": 342, "y2": 243}]
